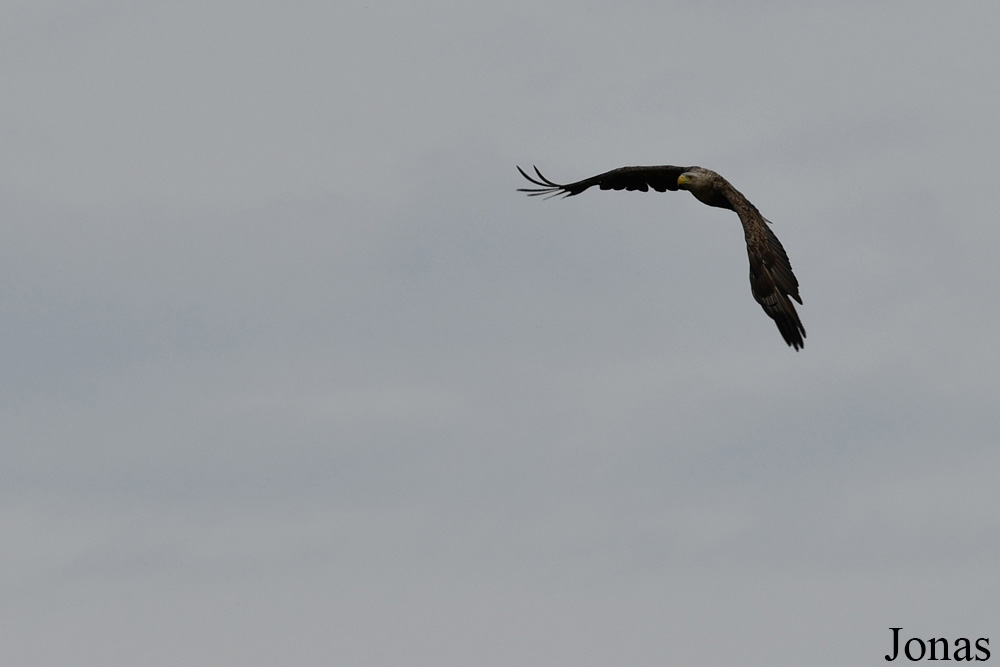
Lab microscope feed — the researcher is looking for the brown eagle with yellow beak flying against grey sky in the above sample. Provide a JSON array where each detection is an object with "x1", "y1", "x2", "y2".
[{"x1": 517, "y1": 165, "x2": 806, "y2": 351}]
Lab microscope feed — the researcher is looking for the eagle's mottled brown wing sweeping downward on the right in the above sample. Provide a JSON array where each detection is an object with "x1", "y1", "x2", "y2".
[{"x1": 727, "y1": 188, "x2": 806, "y2": 350}]
